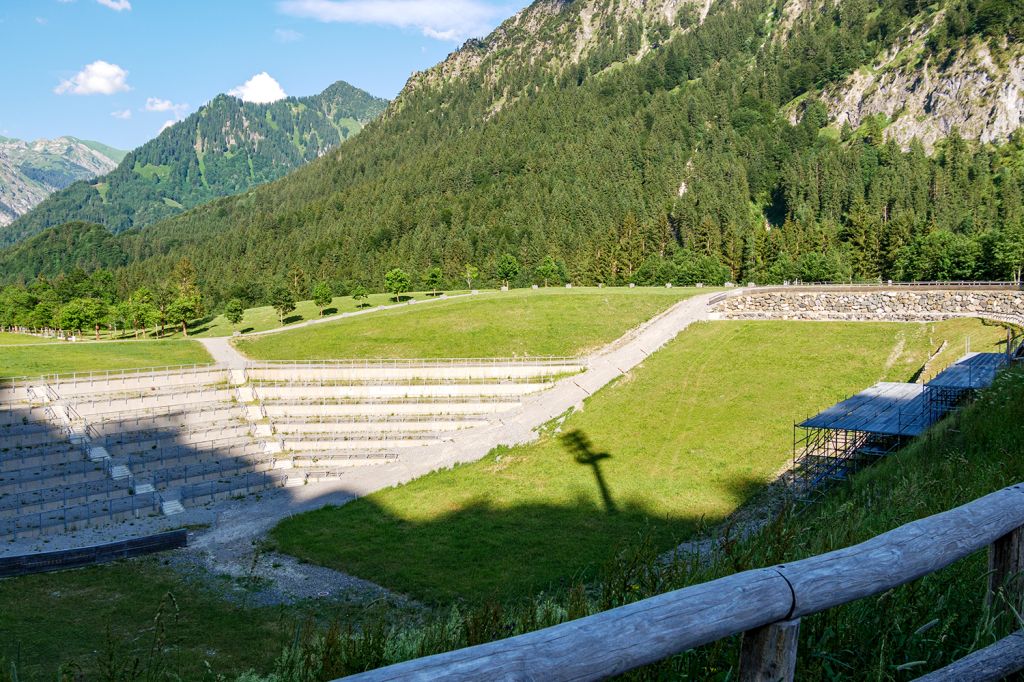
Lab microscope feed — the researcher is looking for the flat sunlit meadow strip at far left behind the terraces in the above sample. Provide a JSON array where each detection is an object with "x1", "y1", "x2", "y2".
[{"x1": 0, "y1": 337, "x2": 213, "y2": 378}]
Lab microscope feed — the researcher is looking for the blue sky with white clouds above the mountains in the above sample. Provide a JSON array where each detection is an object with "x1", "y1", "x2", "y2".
[{"x1": 0, "y1": 0, "x2": 527, "y2": 148}]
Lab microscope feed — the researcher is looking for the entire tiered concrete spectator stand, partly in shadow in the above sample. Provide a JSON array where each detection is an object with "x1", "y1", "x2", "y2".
[{"x1": 0, "y1": 358, "x2": 583, "y2": 539}]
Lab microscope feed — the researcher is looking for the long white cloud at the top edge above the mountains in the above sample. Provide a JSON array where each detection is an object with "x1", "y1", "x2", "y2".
[{"x1": 278, "y1": 0, "x2": 507, "y2": 41}]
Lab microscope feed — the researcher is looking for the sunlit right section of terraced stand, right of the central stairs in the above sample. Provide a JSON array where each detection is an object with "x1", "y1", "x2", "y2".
[{"x1": 247, "y1": 358, "x2": 582, "y2": 484}]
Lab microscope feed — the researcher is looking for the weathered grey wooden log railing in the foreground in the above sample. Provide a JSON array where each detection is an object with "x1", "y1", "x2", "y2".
[{"x1": 348, "y1": 483, "x2": 1024, "y2": 681}]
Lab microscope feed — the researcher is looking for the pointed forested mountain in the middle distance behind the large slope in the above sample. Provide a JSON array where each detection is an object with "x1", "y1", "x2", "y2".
[{"x1": 0, "y1": 81, "x2": 387, "y2": 244}]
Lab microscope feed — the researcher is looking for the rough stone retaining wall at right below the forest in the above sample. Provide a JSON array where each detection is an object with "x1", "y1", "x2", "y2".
[{"x1": 714, "y1": 284, "x2": 1024, "y2": 322}]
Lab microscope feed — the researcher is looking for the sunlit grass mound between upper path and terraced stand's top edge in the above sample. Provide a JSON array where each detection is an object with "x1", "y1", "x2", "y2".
[{"x1": 236, "y1": 288, "x2": 711, "y2": 359}]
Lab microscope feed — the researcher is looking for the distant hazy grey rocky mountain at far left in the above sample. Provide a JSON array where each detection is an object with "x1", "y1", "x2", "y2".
[{"x1": 0, "y1": 137, "x2": 126, "y2": 227}]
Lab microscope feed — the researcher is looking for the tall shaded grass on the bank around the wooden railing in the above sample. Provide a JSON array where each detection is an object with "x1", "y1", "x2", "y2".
[{"x1": 232, "y1": 369, "x2": 1024, "y2": 682}]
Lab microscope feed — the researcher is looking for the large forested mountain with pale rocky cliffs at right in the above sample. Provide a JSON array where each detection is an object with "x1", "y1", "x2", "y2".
[{"x1": 2, "y1": 0, "x2": 1024, "y2": 302}]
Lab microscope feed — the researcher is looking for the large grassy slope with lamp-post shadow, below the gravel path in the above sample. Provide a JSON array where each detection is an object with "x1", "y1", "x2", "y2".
[{"x1": 272, "y1": 321, "x2": 1002, "y2": 601}]
